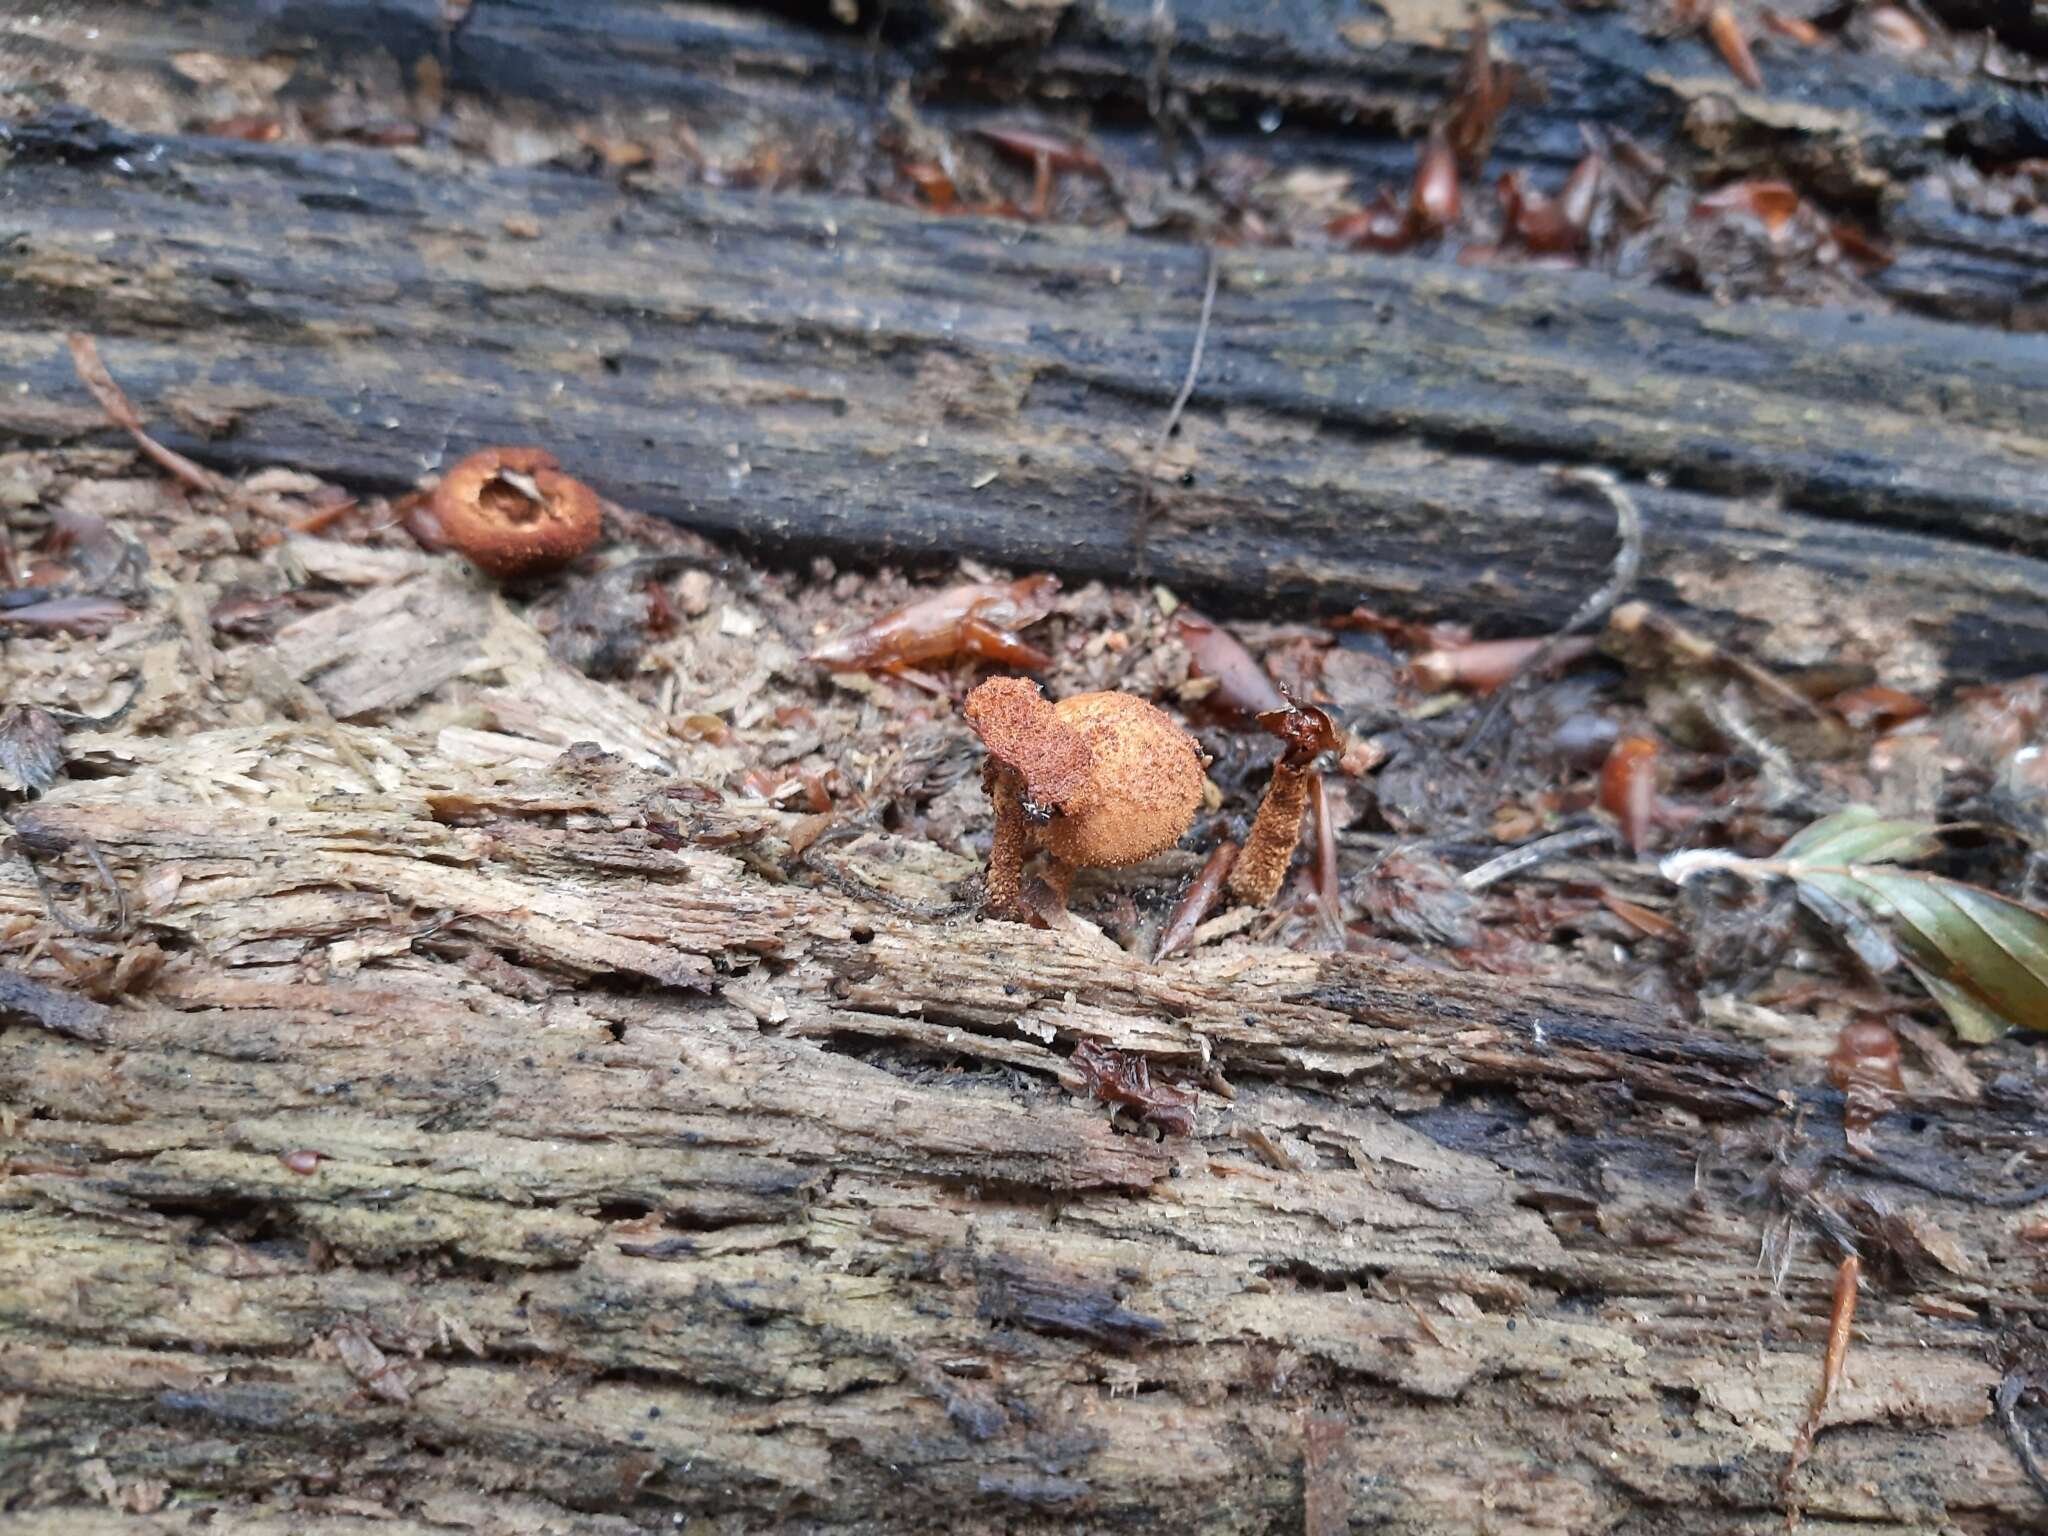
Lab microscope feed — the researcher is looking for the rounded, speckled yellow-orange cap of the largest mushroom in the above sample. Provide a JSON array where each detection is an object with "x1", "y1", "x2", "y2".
[{"x1": 1040, "y1": 692, "x2": 1206, "y2": 868}]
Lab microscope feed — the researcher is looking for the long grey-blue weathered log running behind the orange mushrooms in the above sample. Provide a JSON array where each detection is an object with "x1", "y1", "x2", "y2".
[{"x1": 12, "y1": 8, "x2": 2048, "y2": 678}]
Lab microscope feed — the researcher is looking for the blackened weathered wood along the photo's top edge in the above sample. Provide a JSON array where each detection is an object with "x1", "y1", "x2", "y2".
[{"x1": 24, "y1": 0, "x2": 2048, "y2": 330}]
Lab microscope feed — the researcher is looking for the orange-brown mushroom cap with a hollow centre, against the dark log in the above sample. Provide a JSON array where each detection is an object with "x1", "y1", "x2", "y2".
[{"x1": 430, "y1": 449, "x2": 600, "y2": 578}]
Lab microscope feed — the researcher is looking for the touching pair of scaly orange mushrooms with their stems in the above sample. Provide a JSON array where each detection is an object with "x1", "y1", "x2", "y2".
[{"x1": 967, "y1": 678, "x2": 1206, "y2": 918}]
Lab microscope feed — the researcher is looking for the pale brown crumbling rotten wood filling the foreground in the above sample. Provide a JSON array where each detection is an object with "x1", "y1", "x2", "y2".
[{"x1": 0, "y1": 569, "x2": 2040, "y2": 1532}]
